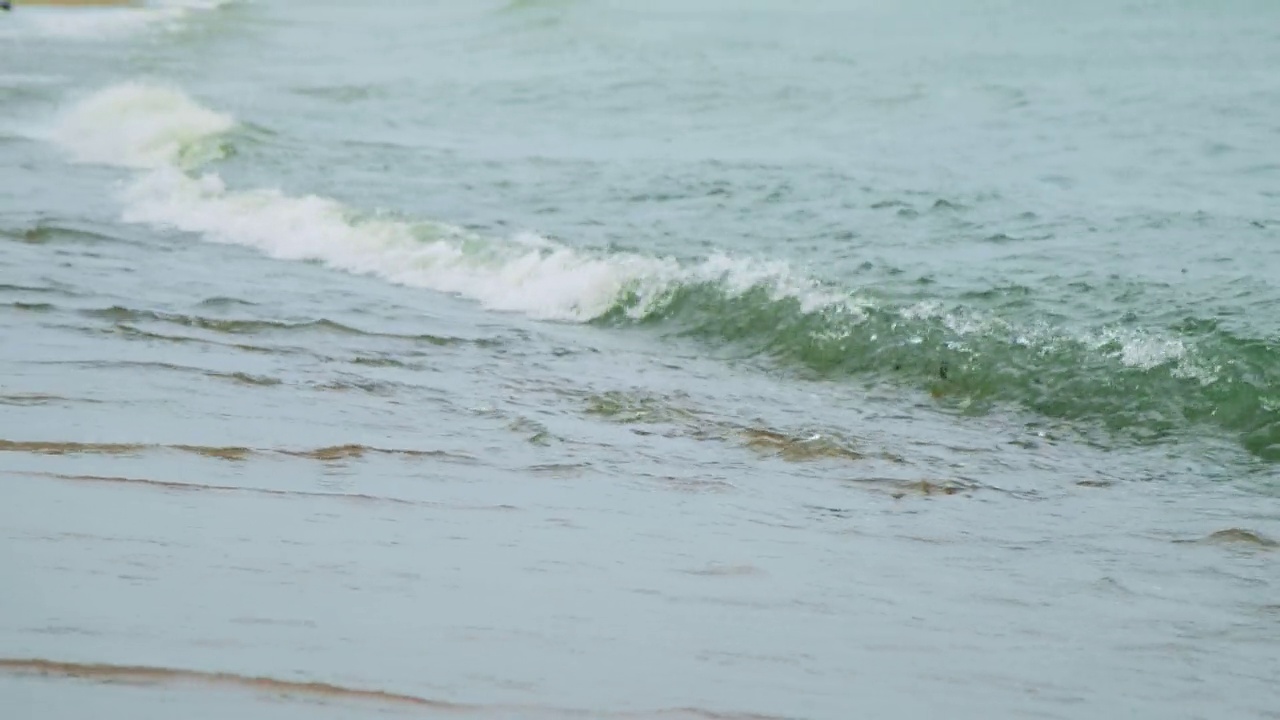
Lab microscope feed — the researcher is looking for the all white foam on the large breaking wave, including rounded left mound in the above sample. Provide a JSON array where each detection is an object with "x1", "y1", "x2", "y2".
[{"x1": 51, "y1": 83, "x2": 858, "y2": 322}]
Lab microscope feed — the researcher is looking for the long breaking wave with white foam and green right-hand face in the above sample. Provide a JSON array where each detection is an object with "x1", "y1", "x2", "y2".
[{"x1": 52, "y1": 83, "x2": 1280, "y2": 460}]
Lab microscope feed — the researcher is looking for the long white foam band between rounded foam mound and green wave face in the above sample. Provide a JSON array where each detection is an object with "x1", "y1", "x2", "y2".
[{"x1": 124, "y1": 168, "x2": 678, "y2": 322}]
